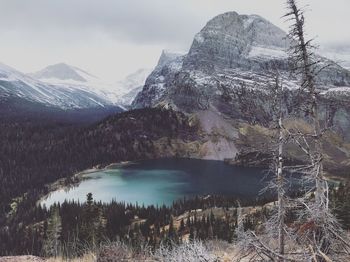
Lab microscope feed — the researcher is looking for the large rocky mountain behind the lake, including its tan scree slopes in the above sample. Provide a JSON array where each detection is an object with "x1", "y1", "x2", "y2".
[{"x1": 132, "y1": 12, "x2": 350, "y2": 172}]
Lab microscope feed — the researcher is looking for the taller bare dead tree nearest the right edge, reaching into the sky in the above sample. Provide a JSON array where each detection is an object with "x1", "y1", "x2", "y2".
[{"x1": 285, "y1": 0, "x2": 350, "y2": 261}]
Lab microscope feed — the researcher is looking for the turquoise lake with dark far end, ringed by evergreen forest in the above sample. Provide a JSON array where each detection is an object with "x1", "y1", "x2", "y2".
[{"x1": 41, "y1": 159, "x2": 267, "y2": 206}]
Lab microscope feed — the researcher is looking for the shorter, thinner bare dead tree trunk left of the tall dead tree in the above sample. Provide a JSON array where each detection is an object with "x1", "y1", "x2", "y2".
[{"x1": 236, "y1": 74, "x2": 295, "y2": 261}]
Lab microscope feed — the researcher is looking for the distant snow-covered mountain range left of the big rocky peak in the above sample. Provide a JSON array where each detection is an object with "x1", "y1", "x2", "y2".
[{"x1": 0, "y1": 63, "x2": 149, "y2": 121}]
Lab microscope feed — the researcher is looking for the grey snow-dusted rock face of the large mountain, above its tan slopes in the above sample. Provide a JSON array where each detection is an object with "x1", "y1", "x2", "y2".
[{"x1": 132, "y1": 12, "x2": 350, "y2": 134}]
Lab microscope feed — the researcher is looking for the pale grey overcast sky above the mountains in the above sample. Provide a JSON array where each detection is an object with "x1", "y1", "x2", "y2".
[{"x1": 0, "y1": 0, "x2": 350, "y2": 81}]
